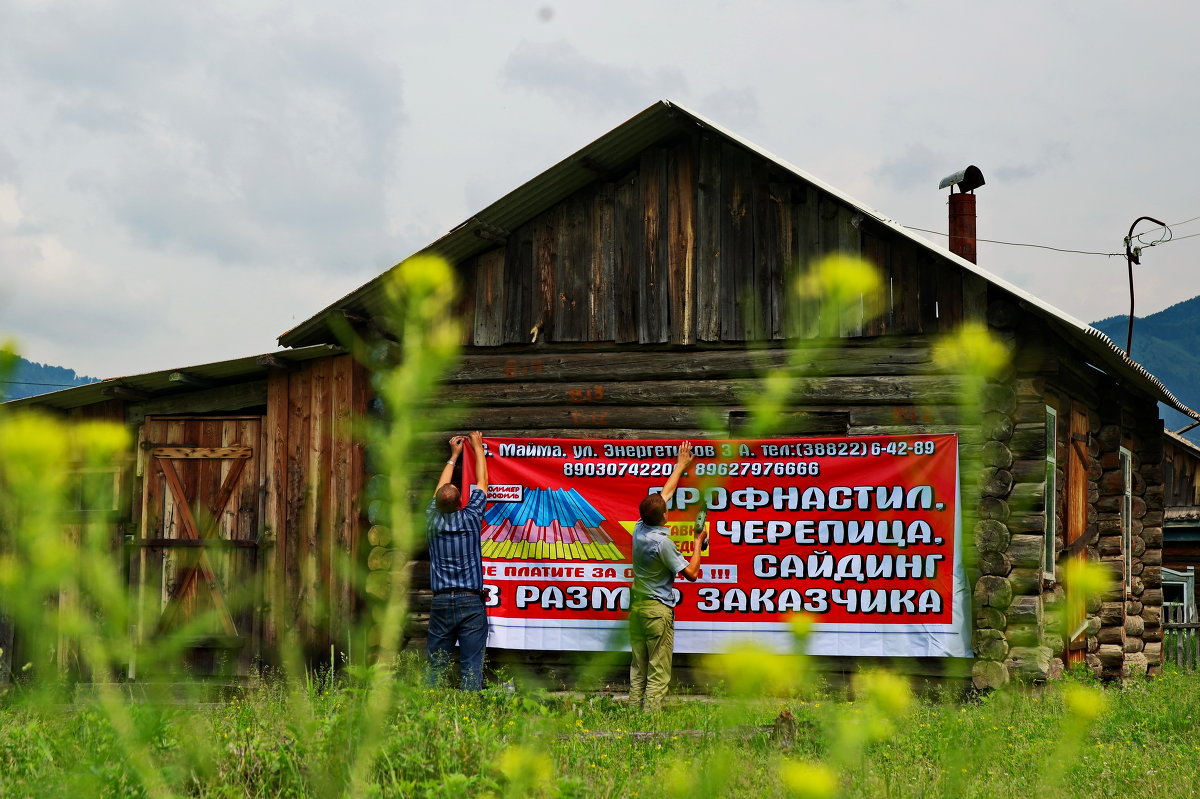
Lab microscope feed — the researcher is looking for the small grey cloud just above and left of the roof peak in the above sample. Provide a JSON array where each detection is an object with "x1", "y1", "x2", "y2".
[{"x1": 502, "y1": 41, "x2": 688, "y2": 113}]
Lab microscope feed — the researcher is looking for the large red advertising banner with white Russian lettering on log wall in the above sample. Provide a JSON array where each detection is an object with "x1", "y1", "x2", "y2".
[{"x1": 463, "y1": 435, "x2": 971, "y2": 657}]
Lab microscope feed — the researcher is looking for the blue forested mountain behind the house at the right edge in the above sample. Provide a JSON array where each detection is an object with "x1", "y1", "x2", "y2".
[{"x1": 1092, "y1": 296, "x2": 1200, "y2": 444}]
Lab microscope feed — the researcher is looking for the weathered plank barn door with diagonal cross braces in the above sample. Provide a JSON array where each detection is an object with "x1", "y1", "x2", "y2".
[{"x1": 131, "y1": 416, "x2": 263, "y2": 675}]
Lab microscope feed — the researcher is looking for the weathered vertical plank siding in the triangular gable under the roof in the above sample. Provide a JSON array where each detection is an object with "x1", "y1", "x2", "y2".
[{"x1": 458, "y1": 134, "x2": 986, "y2": 347}]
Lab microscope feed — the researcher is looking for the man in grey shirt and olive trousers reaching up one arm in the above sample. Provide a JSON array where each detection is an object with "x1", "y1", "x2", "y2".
[{"x1": 629, "y1": 441, "x2": 704, "y2": 713}]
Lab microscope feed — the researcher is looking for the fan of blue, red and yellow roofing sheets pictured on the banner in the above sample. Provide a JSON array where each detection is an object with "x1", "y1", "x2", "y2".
[{"x1": 484, "y1": 487, "x2": 628, "y2": 561}]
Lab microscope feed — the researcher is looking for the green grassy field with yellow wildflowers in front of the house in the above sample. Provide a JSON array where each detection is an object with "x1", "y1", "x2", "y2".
[{"x1": 0, "y1": 673, "x2": 1200, "y2": 798}]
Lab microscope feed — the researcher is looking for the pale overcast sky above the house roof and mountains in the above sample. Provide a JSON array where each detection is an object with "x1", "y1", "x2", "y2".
[{"x1": 0, "y1": 0, "x2": 1200, "y2": 378}]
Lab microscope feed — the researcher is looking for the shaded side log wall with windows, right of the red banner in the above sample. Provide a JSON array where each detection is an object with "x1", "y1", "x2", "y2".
[{"x1": 964, "y1": 302, "x2": 1163, "y2": 687}]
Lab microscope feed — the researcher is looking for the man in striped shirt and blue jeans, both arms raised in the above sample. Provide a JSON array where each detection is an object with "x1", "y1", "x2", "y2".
[{"x1": 426, "y1": 431, "x2": 487, "y2": 691}]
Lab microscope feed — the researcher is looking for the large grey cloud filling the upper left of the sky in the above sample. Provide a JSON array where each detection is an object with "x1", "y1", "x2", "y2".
[{"x1": 0, "y1": 2, "x2": 404, "y2": 269}]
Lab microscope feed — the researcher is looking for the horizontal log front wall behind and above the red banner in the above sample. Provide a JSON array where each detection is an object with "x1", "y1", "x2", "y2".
[{"x1": 391, "y1": 335, "x2": 983, "y2": 684}]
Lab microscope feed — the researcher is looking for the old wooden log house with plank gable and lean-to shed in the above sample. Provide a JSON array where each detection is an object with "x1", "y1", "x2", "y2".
[{"x1": 4, "y1": 102, "x2": 1200, "y2": 687}]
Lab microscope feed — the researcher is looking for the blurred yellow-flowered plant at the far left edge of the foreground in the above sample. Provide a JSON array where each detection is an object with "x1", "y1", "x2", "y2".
[{"x1": 0, "y1": 398, "x2": 180, "y2": 797}]
